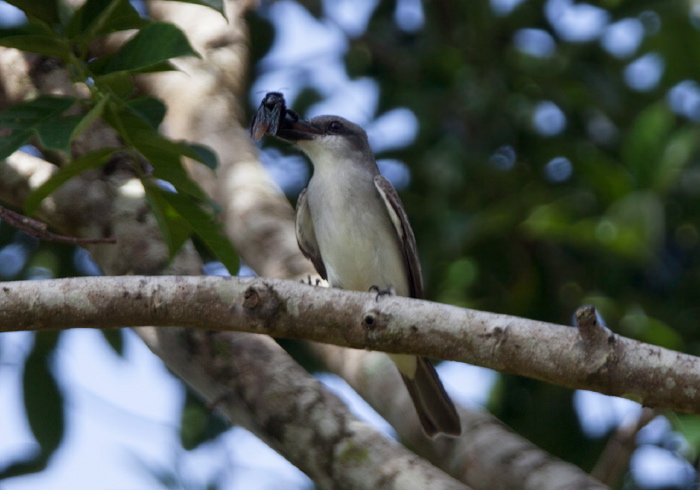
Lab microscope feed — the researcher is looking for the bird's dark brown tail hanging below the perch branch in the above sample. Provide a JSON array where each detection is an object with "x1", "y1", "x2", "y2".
[{"x1": 391, "y1": 356, "x2": 462, "y2": 437}]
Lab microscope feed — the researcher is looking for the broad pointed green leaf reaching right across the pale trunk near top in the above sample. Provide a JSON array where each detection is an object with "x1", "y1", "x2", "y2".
[{"x1": 90, "y1": 22, "x2": 198, "y2": 75}]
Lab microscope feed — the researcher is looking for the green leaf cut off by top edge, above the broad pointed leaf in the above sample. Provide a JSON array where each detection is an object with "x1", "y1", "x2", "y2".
[{"x1": 66, "y1": 0, "x2": 149, "y2": 40}]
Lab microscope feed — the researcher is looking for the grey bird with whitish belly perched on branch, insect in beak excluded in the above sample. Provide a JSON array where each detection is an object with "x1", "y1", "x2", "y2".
[{"x1": 274, "y1": 116, "x2": 462, "y2": 437}]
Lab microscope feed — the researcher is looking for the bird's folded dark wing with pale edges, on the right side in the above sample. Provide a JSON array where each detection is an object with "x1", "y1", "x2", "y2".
[{"x1": 374, "y1": 175, "x2": 424, "y2": 299}]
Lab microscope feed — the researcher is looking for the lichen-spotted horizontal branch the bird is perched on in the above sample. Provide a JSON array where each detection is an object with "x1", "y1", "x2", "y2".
[{"x1": 0, "y1": 277, "x2": 700, "y2": 413}]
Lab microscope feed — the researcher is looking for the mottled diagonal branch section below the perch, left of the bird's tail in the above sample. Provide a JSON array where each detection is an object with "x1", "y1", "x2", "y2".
[{"x1": 138, "y1": 326, "x2": 468, "y2": 490}]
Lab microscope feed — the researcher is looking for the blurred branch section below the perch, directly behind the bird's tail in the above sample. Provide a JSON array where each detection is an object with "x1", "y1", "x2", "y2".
[{"x1": 314, "y1": 344, "x2": 607, "y2": 490}]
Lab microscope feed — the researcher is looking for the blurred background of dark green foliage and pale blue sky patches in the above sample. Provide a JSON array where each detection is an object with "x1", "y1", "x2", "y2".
[{"x1": 0, "y1": 0, "x2": 700, "y2": 489}]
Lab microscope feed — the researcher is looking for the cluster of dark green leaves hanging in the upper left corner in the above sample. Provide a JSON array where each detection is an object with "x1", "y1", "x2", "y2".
[{"x1": 0, "y1": 0, "x2": 238, "y2": 272}]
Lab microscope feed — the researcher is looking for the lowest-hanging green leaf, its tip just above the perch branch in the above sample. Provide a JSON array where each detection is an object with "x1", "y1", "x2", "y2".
[{"x1": 163, "y1": 192, "x2": 239, "y2": 275}]
